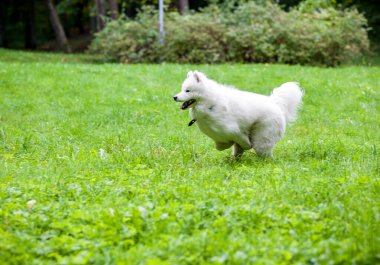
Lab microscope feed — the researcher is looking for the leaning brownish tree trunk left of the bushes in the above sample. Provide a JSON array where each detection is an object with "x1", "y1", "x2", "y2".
[{"x1": 46, "y1": 0, "x2": 71, "y2": 53}]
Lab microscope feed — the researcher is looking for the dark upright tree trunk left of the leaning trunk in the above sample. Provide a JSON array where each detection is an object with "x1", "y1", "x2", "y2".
[{"x1": 22, "y1": 0, "x2": 36, "y2": 49}]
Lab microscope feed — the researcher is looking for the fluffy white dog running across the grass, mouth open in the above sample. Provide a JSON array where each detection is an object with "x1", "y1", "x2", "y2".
[{"x1": 173, "y1": 71, "x2": 302, "y2": 157}]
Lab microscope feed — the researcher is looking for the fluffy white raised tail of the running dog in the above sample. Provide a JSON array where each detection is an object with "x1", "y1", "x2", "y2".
[{"x1": 270, "y1": 82, "x2": 303, "y2": 123}]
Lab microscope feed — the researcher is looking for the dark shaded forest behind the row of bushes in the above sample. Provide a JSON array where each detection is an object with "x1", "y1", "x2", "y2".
[{"x1": 0, "y1": 0, "x2": 380, "y2": 52}]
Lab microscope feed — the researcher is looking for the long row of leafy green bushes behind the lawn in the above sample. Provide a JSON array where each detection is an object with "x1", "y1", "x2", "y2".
[{"x1": 90, "y1": 1, "x2": 369, "y2": 66}]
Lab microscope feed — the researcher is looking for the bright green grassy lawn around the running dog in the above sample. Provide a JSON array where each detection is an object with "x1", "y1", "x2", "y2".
[{"x1": 0, "y1": 50, "x2": 380, "y2": 264}]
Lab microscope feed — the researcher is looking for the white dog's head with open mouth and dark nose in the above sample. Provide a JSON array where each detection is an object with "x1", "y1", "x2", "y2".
[{"x1": 173, "y1": 71, "x2": 207, "y2": 110}]
